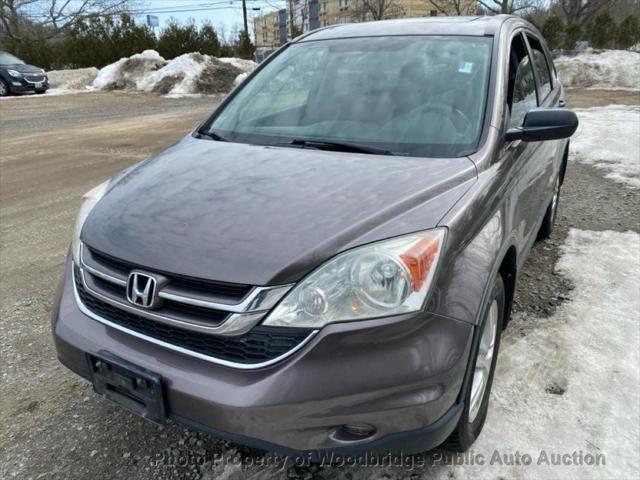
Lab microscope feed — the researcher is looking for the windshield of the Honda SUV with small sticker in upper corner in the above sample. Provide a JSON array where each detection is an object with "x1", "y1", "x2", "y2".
[{"x1": 202, "y1": 36, "x2": 491, "y2": 157}]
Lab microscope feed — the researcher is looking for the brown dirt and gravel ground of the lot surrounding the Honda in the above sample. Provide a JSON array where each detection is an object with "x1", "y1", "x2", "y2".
[{"x1": 0, "y1": 91, "x2": 640, "y2": 479}]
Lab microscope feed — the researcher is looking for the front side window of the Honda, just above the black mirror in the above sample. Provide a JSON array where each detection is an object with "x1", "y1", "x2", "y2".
[{"x1": 507, "y1": 35, "x2": 538, "y2": 128}]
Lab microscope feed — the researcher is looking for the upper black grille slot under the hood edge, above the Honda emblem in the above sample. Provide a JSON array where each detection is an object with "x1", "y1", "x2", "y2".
[{"x1": 89, "y1": 248, "x2": 251, "y2": 301}]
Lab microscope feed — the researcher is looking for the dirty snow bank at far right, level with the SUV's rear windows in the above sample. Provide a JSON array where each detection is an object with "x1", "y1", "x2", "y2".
[{"x1": 554, "y1": 50, "x2": 640, "y2": 90}]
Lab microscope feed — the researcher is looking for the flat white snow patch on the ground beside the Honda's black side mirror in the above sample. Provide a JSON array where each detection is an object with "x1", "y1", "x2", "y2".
[{"x1": 570, "y1": 105, "x2": 640, "y2": 188}]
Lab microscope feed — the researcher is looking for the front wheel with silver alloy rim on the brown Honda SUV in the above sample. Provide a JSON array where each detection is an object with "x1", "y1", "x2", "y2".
[{"x1": 443, "y1": 275, "x2": 505, "y2": 452}]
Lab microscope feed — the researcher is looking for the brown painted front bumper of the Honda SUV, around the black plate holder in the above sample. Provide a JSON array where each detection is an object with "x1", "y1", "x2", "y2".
[{"x1": 53, "y1": 261, "x2": 473, "y2": 454}]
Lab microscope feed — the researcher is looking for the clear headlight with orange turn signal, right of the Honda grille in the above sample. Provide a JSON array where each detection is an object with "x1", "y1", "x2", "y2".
[{"x1": 264, "y1": 228, "x2": 445, "y2": 328}]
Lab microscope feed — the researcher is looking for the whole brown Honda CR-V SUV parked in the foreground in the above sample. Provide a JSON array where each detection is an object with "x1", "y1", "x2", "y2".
[{"x1": 53, "y1": 16, "x2": 577, "y2": 454}]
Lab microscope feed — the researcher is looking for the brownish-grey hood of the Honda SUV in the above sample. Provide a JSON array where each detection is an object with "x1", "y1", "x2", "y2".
[{"x1": 82, "y1": 137, "x2": 476, "y2": 285}]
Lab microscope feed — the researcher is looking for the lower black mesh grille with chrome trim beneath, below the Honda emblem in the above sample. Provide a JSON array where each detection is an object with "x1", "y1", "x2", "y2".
[{"x1": 74, "y1": 268, "x2": 311, "y2": 365}]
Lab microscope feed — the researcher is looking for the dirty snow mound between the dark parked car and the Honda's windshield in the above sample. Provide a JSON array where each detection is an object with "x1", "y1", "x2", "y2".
[{"x1": 93, "y1": 50, "x2": 256, "y2": 95}]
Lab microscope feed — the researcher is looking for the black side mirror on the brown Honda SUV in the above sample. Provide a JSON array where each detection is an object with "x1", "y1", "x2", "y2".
[{"x1": 505, "y1": 108, "x2": 578, "y2": 142}]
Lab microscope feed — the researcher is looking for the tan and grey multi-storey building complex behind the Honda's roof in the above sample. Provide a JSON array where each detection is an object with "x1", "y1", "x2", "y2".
[{"x1": 253, "y1": 0, "x2": 477, "y2": 48}]
